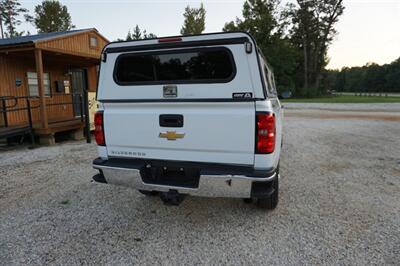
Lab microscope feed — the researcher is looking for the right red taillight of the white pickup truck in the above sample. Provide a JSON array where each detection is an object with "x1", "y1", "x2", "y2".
[{"x1": 256, "y1": 113, "x2": 276, "y2": 153}]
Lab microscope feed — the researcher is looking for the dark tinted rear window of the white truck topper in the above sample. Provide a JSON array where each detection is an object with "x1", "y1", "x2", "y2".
[{"x1": 114, "y1": 47, "x2": 236, "y2": 85}]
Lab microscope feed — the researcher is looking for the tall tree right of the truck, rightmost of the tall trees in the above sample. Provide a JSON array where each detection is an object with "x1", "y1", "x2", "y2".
[{"x1": 286, "y1": 0, "x2": 344, "y2": 96}]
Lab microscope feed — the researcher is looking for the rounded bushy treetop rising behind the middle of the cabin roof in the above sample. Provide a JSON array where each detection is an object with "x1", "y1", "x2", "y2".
[{"x1": 33, "y1": 0, "x2": 75, "y2": 32}]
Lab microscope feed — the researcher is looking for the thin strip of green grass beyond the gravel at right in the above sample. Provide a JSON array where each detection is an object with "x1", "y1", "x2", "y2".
[{"x1": 282, "y1": 95, "x2": 400, "y2": 103}]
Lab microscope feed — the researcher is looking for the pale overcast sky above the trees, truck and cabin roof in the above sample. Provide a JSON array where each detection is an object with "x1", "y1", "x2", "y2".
[{"x1": 20, "y1": 0, "x2": 400, "y2": 68}]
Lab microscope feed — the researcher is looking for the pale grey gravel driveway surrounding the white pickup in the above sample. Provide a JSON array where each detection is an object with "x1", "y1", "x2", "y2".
[{"x1": 0, "y1": 105, "x2": 400, "y2": 265}]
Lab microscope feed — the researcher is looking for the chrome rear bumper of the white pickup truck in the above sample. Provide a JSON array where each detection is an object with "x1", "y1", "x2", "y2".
[{"x1": 93, "y1": 159, "x2": 279, "y2": 198}]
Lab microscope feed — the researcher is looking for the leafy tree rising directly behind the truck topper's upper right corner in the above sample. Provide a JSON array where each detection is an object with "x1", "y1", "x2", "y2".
[{"x1": 223, "y1": 0, "x2": 299, "y2": 90}]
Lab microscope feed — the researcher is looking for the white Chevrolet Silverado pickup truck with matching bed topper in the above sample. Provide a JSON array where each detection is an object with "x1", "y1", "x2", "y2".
[{"x1": 93, "y1": 32, "x2": 283, "y2": 209}]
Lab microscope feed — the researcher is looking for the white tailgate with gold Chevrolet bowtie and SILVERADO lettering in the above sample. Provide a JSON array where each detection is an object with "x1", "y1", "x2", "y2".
[{"x1": 104, "y1": 101, "x2": 255, "y2": 165}]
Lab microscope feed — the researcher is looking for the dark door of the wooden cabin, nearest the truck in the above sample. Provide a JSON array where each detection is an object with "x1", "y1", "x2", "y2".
[{"x1": 71, "y1": 69, "x2": 87, "y2": 117}]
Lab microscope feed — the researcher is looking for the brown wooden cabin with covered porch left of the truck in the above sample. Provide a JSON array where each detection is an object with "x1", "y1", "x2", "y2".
[{"x1": 0, "y1": 29, "x2": 108, "y2": 144}]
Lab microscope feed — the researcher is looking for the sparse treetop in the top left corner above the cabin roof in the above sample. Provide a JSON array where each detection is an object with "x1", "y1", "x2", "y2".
[{"x1": 0, "y1": 0, "x2": 32, "y2": 38}]
